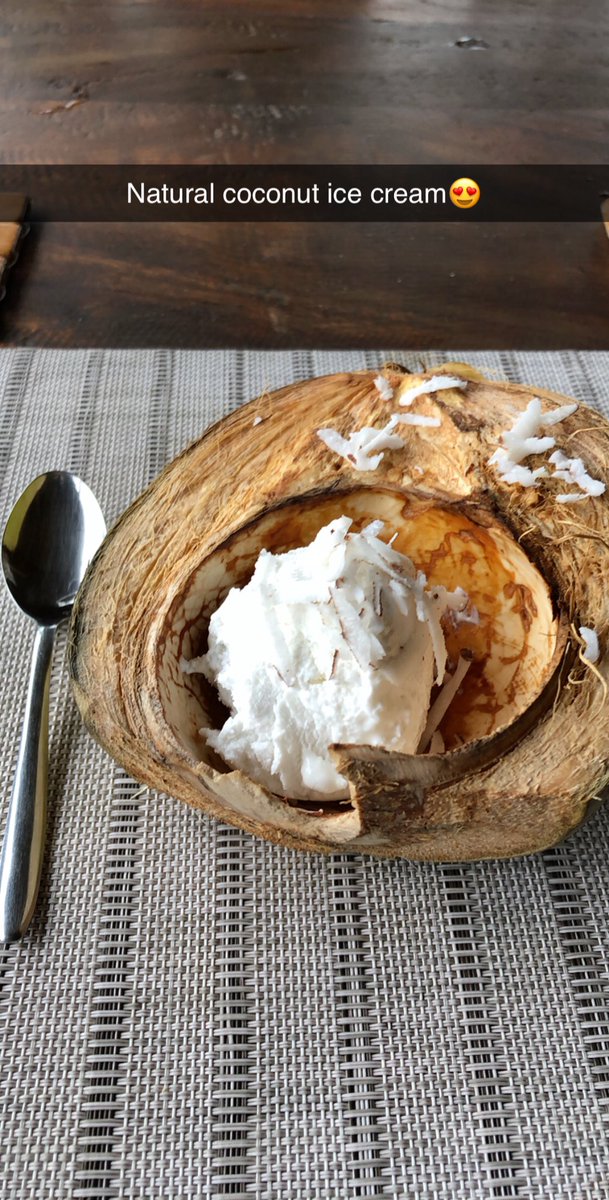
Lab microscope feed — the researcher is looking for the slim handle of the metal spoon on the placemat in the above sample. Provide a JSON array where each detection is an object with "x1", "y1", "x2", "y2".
[{"x1": 0, "y1": 625, "x2": 56, "y2": 942}]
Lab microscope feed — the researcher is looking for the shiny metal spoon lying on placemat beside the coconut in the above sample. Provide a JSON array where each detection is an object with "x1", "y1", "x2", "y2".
[{"x1": 0, "y1": 470, "x2": 105, "y2": 942}]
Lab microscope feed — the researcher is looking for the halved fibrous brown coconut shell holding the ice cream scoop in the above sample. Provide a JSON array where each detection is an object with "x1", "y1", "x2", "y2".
[{"x1": 70, "y1": 364, "x2": 609, "y2": 860}]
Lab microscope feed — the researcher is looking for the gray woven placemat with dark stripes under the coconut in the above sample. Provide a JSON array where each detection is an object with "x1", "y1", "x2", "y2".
[{"x1": 0, "y1": 349, "x2": 609, "y2": 1200}]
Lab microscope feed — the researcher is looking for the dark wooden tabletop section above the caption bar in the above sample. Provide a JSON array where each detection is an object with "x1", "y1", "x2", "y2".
[{"x1": 0, "y1": 0, "x2": 609, "y2": 162}]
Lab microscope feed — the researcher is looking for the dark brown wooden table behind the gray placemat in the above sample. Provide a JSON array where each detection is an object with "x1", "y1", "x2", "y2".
[{"x1": 0, "y1": 0, "x2": 609, "y2": 348}]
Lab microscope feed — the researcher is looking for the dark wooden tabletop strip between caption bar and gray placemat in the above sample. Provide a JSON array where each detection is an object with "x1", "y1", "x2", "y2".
[{"x1": 0, "y1": 221, "x2": 609, "y2": 348}]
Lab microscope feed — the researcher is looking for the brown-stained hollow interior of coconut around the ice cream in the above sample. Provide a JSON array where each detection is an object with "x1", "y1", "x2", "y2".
[{"x1": 156, "y1": 487, "x2": 566, "y2": 811}]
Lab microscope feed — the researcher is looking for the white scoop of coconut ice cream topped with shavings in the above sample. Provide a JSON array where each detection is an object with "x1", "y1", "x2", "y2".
[{"x1": 183, "y1": 517, "x2": 468, "y2": 800}]
